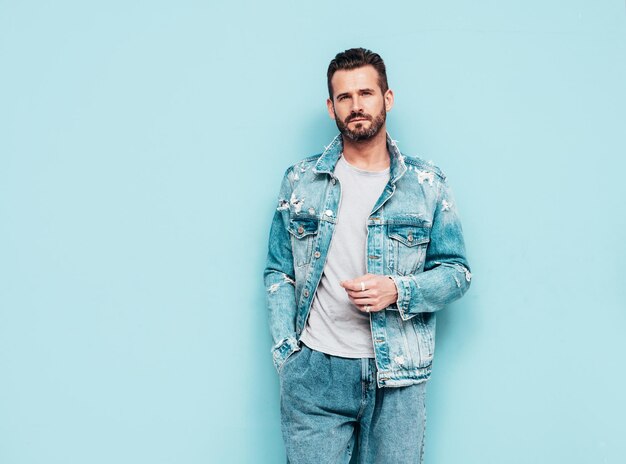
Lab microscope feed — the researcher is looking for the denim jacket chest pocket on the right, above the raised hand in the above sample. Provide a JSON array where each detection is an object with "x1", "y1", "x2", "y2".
[{"x1": 387, "y1": 223, "x2": 430, "y2": 275}]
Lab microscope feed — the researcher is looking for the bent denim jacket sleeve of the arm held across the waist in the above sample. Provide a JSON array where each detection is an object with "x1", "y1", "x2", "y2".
[{"x1": 391, "y1": 178, "x2": 472, "y2": 321}]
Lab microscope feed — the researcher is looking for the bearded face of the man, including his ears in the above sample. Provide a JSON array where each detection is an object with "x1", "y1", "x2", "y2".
[{"x1": 326, "y1": 65, "x2": 393, "y2": 142}]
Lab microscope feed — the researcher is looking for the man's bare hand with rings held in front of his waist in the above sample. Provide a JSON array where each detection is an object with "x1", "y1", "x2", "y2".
[{"x1": 339, "y1": 274, "x2": 398, "y2": 313}]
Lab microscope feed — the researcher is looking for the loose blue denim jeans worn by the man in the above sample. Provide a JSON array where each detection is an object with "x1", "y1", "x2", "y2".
[{"x1": 280, "y1": 344, "x2": 426, "y2": 464}]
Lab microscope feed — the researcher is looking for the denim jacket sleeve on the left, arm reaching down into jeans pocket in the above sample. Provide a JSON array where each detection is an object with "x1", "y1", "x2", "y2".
[{"x1": 263, "y1": 169, "x2": 299, "y2": 371}]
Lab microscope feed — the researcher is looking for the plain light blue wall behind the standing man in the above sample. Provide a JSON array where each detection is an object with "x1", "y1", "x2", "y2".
[{"x1": 0, "y1": 0, "x2": 626, "y2": 464}]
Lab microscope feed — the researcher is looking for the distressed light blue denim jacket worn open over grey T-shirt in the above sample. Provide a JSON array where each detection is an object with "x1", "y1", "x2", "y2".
[{"x1": 264, "y1": 134, "x2": 471, "y2": 387}]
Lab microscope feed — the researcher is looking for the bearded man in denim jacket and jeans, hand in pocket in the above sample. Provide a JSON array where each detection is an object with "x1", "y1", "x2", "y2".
[{"x1": 264, "y1": 48, "x2": 471, "y2": 464}]
